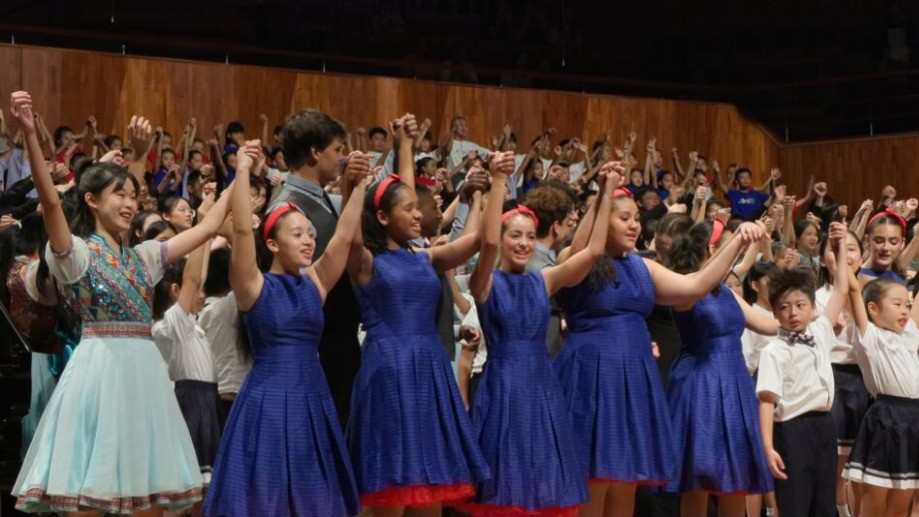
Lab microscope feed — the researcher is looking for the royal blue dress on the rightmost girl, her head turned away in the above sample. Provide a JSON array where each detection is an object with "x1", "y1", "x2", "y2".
[{"x1": 666, "y1": 285, "x2": 773, "y2": 494}]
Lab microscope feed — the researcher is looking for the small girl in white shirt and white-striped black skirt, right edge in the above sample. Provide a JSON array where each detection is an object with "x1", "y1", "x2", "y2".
[{"x1": 843, "y1": 274, "x2": 919, "y2": 515}]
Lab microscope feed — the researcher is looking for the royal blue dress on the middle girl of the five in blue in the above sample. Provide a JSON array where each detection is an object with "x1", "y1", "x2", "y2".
[{"x1": 468, "y1": 271, "x2": 587, "y2": 516}]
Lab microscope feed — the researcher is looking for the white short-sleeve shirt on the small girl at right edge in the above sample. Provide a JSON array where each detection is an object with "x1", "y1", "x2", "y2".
[{"x1": 856, "y1": 318, "x2": 919, "y2": 399}]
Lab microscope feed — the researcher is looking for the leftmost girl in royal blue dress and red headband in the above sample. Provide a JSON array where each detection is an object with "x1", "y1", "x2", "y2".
[{"x1": 204, "y1": 141, "x2": 370, "y2": 517}]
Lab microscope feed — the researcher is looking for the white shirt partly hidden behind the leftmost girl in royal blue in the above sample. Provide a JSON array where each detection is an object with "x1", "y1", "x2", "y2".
[{"x1": 198, "y1": 293, "x2": 252, "y2": 394}]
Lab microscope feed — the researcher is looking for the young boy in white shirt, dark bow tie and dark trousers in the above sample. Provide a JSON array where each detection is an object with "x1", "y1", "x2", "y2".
[{"x1": 756, "y1": 223, "x2": 848, "y2": 517}]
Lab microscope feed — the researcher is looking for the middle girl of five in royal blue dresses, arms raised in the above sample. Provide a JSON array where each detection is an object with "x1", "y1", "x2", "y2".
[{"x1": 464, "y1": 159, "x2": 625, "y2": 517}]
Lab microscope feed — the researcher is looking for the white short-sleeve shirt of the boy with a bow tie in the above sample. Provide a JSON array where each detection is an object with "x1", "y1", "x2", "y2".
[{"x1": 756, "y1": 316, "x2": 836, "y2": 422}]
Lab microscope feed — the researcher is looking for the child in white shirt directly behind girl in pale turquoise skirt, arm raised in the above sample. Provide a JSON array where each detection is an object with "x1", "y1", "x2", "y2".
[{"x1": 153, "y1": 237, "x2": 220, "y2": 492}]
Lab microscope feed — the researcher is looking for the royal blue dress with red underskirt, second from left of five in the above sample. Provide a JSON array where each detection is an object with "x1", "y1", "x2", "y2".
[{"x1": 347, "y1": 249, "x2": 490, "y2": 506}]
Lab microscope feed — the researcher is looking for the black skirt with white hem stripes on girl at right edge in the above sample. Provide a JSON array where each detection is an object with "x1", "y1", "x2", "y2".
[{"x1": 843, "y1": 395, "x2": 919, "y2": 490}]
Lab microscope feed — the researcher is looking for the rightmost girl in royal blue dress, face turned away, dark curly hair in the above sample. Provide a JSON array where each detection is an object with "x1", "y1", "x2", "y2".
[{"x1": 666, "y1": 221, "x2": 778, "y2": 517}]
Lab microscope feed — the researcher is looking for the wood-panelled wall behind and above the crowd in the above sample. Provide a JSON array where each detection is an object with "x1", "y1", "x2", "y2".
[{"x1": 0, "y1": 45, "x2": 919, "y2": 208}]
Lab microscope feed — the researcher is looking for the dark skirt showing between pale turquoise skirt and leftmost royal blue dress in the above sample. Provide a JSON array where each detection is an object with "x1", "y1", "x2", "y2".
[{"x1": 175, "y1": 380, "x2": 220, "y2": 485}]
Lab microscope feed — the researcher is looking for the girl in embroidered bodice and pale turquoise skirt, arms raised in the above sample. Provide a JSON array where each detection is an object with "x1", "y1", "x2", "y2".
[{"x1": 11, "y1": 92, "x2": 227, "y2": 515}]
